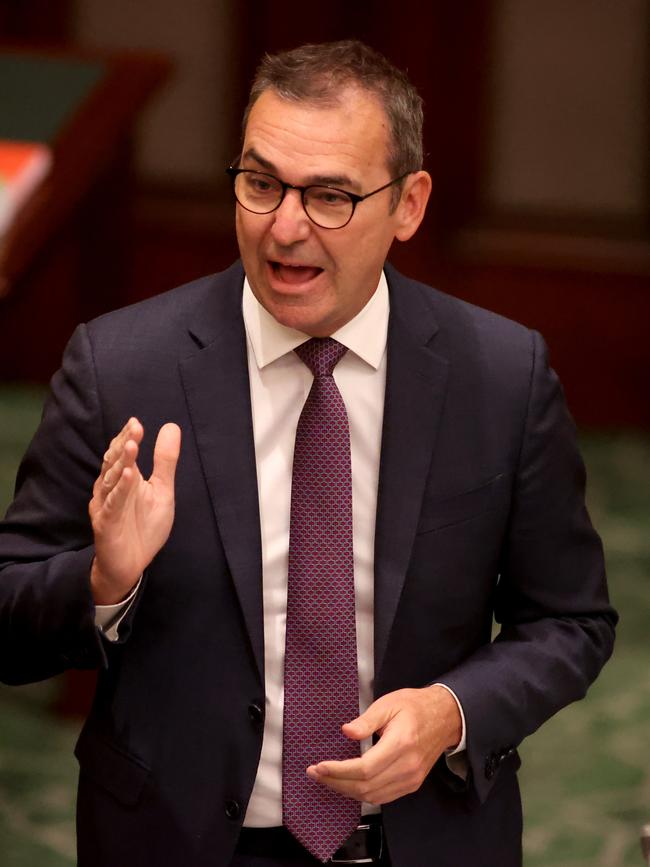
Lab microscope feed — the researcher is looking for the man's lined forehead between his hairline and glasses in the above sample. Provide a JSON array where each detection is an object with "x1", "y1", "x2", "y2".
[{"x1": 243, "y1": 88, "x2": 389, "y2": 177}]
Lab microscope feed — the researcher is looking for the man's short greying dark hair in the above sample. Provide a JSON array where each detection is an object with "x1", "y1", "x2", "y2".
[{"x1": 243, "y1": 39, "x2": 423, "y2": 207}]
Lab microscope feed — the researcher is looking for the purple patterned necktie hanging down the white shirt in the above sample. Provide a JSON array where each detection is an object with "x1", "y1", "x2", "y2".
[{"x1": 282, "y1": 337, "x2": 360, "y2": 861}]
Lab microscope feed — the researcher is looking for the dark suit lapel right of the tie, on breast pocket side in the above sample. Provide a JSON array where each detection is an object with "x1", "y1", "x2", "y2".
[{"x1": 374, "y1": 268, "x2": 448, "y2": 681}]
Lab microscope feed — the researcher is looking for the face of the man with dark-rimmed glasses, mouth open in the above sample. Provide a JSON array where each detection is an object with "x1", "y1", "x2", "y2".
[{"x1": 236, "y1": 89, "x2": 419, "y2": 337}]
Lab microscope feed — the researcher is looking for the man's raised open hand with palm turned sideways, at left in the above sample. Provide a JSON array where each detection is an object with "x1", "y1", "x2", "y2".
[{"x1": 88, "y1": 418, "x2": 181, "y2": 605}]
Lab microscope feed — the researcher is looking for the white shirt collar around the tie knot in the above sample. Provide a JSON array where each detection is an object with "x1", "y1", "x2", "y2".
[{"x1": 242, "y1": 271, "x2": 389, "y2": 370}]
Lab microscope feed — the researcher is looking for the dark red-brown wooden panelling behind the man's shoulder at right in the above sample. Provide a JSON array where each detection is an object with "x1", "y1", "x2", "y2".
[{"x1": 445, "y1": 265, "x2": 650, "y2": 429}]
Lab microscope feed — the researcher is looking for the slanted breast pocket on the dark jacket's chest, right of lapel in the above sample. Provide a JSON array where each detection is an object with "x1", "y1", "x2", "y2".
[{"x1": 417, "y1": 473, "x2": 510, "y2": 534}]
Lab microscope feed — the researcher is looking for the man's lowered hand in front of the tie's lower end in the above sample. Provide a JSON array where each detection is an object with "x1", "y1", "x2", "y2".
[{"x1": 307, "y1": 685, "x2": 462, "y2": 804}]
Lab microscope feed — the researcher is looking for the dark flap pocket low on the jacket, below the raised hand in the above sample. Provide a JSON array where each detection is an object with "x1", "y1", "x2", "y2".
[{"x1": 74, "y1": 730, "x2": 150, "y2": 806}]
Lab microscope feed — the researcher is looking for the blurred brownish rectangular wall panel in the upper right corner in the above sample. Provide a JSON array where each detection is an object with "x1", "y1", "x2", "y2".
[{"x1": 486, "y1": 0, "x2": 650, "y2": 216}]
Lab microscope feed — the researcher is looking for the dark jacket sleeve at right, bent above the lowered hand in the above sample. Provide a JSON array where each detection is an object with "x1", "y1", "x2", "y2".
[{"x1": 439, "y1": 334, "x2": 617, "y2": 800}]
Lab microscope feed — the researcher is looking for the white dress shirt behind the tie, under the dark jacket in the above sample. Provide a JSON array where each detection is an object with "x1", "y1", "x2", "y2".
[{"x1": 243, "y1": 274, "x2": 388, "y2": 827}]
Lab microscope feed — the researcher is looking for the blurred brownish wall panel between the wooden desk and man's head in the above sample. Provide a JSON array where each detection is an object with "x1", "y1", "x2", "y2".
[{"x1": 75, "y1": 0, "x2": 236, "y2": 185}]
